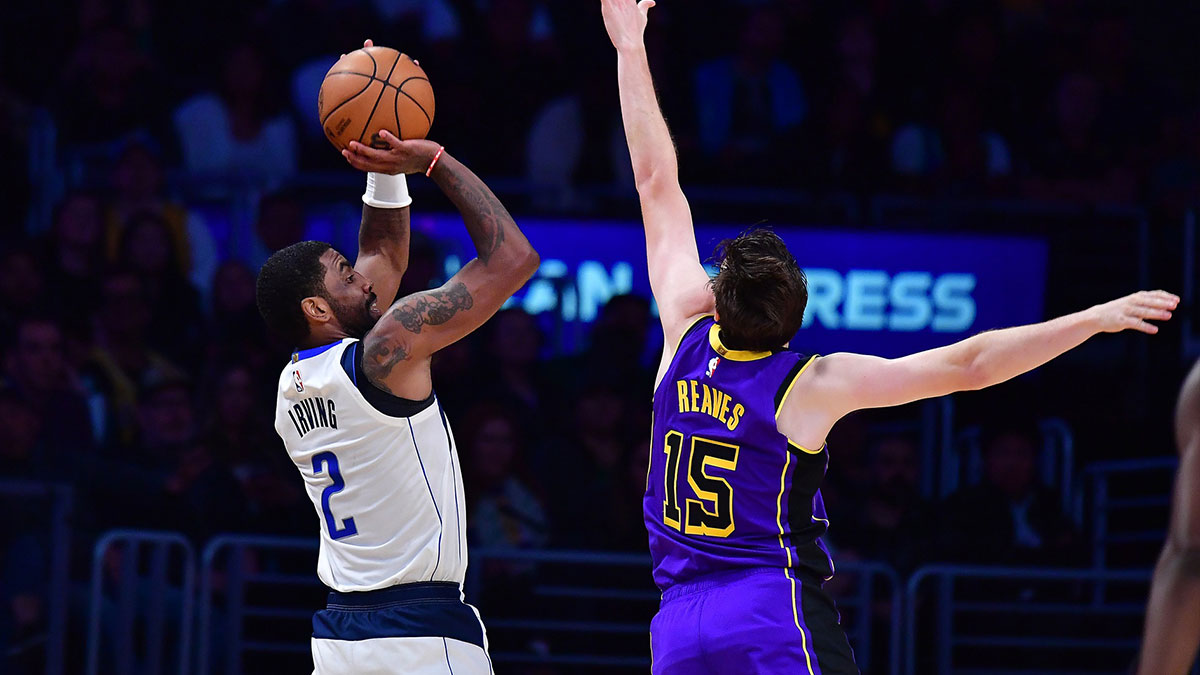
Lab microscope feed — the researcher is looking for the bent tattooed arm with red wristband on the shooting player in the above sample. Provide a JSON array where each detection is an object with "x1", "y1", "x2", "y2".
[{"x1": 350, "y1": 139, "x2": 539, "y2": 399}]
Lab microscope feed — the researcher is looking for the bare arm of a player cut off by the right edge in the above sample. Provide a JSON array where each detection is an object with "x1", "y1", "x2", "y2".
[{"x1": 1138, "y1": 362, "x2": 1200, "y2": 675}]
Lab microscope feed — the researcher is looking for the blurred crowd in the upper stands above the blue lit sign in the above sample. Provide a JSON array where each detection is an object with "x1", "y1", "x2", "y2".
[{"x1": 0, "y1": 0, "x2": 1200, "y2": 215}]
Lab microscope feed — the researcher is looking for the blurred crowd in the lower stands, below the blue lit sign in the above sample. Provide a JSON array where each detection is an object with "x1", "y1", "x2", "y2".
[{"x1": 0, "y1": 210, "x2": 1082, "y2": 653}]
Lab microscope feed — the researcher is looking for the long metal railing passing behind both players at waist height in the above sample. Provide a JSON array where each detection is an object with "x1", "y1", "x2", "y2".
[{"x1": 189, "y1": 536, "x2": 902, "y2": 675}]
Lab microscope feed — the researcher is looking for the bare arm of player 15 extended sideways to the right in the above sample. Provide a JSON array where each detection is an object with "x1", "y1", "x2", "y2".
[{"x1": 779, "y1": 291, "x2": 1180, "y2": 448}]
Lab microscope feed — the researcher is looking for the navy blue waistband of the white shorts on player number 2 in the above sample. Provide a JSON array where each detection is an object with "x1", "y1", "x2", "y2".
[{"x1": 312, "y1": 581, "x2": 484, "y2": 652}]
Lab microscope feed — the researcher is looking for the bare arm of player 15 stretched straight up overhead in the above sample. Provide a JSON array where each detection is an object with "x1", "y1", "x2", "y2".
[{"x1": 602, "y1": 0, "x2": 714, "y2": 345}]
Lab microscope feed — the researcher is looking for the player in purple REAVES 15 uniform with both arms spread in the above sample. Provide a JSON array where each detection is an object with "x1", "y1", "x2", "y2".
[{"x1": 602, "y1": 0, "x2": 1178, "y2": 675}]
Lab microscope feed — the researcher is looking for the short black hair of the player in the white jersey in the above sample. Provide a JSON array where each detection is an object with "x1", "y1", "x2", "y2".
[{"x1": 254, "y1": 241, "x2": 332, "y2": 346}]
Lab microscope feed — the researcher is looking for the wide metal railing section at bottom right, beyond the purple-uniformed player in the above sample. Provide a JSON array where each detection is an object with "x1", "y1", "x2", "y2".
[{"x1": 904, "y1": 566, "x2": 1151, "y2": 675}]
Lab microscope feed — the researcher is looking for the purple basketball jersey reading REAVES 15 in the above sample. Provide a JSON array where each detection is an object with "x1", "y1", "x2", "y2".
[{"x1": 642, "y1": 317, "x2": 833, "y2": 590}]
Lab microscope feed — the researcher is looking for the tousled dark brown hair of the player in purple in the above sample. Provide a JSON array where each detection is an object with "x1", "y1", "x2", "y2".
[{"x1": 713, "y1": 229, "x2": 809, "y2": 351}]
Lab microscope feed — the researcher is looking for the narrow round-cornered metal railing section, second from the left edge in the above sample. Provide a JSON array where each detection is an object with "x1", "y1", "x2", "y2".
[{"x1": 86, "y1": 530, "x2": 196, "y2": 675}]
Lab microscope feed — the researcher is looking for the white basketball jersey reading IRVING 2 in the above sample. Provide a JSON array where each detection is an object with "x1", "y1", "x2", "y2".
[{"x1": 275, "y1": 339, "x2": 467, "y2": 592}]
